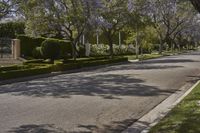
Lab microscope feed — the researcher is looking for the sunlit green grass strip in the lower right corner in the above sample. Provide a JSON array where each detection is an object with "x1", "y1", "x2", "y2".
[{"x1": 150, "y1": 84, "x2": 200, "y2": 133}]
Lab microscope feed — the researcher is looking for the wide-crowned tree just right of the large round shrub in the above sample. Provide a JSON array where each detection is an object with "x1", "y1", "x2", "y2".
[{"x1": 19, "y1": 0, "x2": 101, "y2": 60}]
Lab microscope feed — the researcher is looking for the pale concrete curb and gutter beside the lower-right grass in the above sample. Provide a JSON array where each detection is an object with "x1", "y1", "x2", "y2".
[{"x1": 122, "y1": 81, "x2": 200, "y2": 133}]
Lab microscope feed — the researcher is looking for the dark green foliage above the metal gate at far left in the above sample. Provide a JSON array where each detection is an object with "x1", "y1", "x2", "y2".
[{"x1": 0, "y1": 22, "x2": 25, "y2": 39}]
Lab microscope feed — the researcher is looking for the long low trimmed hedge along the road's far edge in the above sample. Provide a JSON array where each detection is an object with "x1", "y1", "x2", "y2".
[{"x1": 0, "y1": 57, "x2": 128, "y2": 80}]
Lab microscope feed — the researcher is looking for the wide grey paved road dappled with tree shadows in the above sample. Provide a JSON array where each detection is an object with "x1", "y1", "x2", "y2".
[{"x1": 0, "y1": 52, "x2": 200, "y2": 133}]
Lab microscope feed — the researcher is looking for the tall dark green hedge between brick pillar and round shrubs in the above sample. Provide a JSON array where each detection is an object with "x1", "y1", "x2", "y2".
[{"x1": 17, "y1": 35, "x2": 46, "y2": 57}]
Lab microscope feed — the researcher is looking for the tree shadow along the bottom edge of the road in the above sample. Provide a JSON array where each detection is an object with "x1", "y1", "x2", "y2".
[{"x1": 7, "y1": 119, "x2": 148, "y2": 133}]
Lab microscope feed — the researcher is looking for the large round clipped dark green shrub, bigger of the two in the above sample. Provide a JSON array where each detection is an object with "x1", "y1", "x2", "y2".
[{"x1": 42, "y1": 39, "x2": 61, "y2": 61}]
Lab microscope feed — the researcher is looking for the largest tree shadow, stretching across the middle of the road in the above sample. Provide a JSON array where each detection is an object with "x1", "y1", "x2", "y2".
[{"x1": 0, "y1": 73, "x2": 174, "y2": 99}]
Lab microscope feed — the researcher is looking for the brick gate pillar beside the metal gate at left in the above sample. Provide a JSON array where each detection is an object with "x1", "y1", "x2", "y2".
[{"x1": 12, "y1": 39, "x2": 21, "y2": 59}]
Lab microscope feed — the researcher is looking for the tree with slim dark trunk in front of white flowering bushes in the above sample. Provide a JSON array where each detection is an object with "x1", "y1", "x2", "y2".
[{"x1": 97, "y1": 0, "x2": 128, "y2": 58}]
